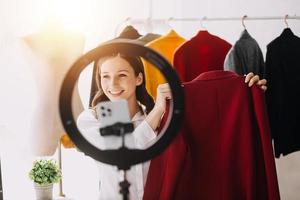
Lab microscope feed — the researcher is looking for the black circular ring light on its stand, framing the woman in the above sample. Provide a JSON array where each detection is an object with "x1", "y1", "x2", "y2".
[{"x1": 59, "y1": 39, "x2": 184, "y2": 199}]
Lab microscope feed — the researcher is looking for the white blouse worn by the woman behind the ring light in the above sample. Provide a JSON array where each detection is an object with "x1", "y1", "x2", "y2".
[{"x1": 77, "y1": 109, "x2": 156, "y2": 200}]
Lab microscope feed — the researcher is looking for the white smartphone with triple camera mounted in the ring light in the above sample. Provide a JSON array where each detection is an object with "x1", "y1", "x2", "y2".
[{"x1": 96, "y1": 100, "x2": 131, "y2": 135}]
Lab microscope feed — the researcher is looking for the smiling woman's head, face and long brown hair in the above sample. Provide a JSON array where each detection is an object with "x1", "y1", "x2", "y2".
[{"x1": 92, "y1": 54, "x2": 154, "y2": 117}]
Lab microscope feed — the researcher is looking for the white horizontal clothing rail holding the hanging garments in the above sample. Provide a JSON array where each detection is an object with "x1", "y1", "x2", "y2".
[{"x1": 115, "y1": 15, "x2": 300, "y2": 35}]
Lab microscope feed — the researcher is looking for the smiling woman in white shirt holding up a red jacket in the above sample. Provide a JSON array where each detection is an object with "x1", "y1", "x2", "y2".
[{"x1": 77, "y1": 54, "x2": 266, "y2": 200}]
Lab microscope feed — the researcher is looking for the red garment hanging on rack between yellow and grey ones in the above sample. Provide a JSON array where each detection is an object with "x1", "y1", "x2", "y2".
[{"x1": 173, "y1": 31, "x2": 231, "y2": 82}]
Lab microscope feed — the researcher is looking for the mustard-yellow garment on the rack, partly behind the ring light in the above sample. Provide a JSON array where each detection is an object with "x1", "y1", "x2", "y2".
[{"x1": 143, "y1": 30, "x2": 186, "y2": 99}]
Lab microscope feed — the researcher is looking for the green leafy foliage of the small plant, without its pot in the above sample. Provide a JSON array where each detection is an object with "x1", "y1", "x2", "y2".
[{"x1": 29, "y1": 159, "x2": 61, "y2": 185}]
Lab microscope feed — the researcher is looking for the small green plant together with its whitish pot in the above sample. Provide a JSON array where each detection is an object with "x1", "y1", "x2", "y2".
[{"x1": 29, "y1": 159, "x2": 61, "y2": 200}]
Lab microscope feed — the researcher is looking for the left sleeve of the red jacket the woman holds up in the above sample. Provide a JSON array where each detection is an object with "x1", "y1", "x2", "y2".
[{"x1": 143, "y1": 131, "x2": 188, "y2": 200}]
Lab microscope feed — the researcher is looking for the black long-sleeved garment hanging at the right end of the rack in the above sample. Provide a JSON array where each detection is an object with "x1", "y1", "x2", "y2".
[{"x1": 266, "y1": 28, "x2": 300, "y2": 158}]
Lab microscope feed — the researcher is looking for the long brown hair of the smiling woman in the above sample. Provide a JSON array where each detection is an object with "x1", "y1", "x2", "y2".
[{"x1": 92, "y1": 53, "x2": 154, "y2": 114}]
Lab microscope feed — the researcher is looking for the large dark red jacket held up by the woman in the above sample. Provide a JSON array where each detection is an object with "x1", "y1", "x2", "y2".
[{"x1": 143, "y1": 71, "x2": 280, "y2": 200}]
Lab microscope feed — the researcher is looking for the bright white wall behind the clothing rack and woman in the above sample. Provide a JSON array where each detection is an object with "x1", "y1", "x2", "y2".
[{"x1": 0, "y1": 0, "x2": 300, "y2": 200}]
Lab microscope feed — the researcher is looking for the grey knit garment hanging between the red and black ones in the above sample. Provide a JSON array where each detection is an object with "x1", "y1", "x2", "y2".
[{"x1": 224, "y1": 29, "x2": 265, "y2": 78}]
